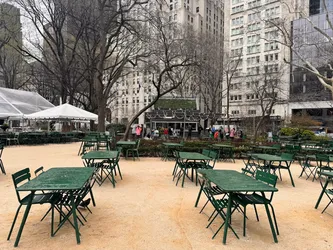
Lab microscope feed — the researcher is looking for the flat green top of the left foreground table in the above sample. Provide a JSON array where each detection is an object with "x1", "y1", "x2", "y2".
[{"x1": 16, "y1": 167, "x2": 94, "y2": 191}]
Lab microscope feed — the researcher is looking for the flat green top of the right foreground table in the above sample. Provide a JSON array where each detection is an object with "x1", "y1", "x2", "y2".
[{"x1": 198, "y1": 169, "x2": 278, "y2": 192}]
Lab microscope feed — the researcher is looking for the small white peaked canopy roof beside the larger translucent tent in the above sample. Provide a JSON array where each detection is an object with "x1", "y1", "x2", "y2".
[{"x1": 24, "y1": 103, "x2": 98, "y2": 121}]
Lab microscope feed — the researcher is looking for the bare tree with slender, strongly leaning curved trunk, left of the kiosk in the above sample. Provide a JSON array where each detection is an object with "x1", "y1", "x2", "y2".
[{"x1": 124, "y1": 4, "x2": 197, "y2": 139}]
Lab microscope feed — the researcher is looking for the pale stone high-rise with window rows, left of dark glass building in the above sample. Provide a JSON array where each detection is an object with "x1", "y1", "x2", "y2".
[{"x1": 223, "y1": 0, "x2": 303, "y2": 129}]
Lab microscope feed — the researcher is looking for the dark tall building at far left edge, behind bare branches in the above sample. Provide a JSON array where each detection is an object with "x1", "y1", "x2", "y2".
[{"x1": 0, "y1": 3, "x2": 22, "y2": 88}]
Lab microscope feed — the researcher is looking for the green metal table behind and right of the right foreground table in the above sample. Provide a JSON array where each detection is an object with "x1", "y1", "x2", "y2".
[{"x1": 249, "y1": 154, "x2": 295, "y2": 187}]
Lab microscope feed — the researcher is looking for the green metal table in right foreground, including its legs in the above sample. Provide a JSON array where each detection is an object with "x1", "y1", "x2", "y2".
[{"x1": 195, "y1": 169, "x2": 278, "y2": 244}]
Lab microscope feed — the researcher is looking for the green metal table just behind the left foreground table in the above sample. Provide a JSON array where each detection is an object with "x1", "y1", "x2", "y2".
[{"x1": 81, "y1": 151, "x2": 121, "y2": 187}]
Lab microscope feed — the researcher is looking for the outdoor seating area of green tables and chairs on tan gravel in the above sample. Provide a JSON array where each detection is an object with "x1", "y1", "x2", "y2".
[{"x1": 0, "y1": 141, "x2": 333, "y2": 249}]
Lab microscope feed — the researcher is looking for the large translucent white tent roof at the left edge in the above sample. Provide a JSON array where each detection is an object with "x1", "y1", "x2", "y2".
[{"x1": 0, "y1": 88, "x2": 54, "y2": 119}]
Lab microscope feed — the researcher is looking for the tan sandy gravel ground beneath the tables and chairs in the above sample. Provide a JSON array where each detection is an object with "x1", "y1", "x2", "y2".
[{"x1": 0, "y1": 143, "x2": 333, "y2": 250}]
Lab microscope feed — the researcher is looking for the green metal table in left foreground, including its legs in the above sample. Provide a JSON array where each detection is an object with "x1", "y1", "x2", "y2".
[{"x1": 14, "y1": 167, "x2": 95, "y2": 247}]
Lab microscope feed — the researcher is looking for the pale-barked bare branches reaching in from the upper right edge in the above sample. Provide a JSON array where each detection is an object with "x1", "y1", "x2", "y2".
[{"x1": 263, "y1": 0, "x2": 333, "y2": 95}]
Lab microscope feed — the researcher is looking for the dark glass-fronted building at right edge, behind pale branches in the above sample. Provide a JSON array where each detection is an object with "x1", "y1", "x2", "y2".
[{"x1": 289, "y1": 9, "x2": 333, "y2": 127}]
